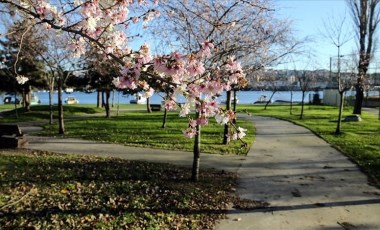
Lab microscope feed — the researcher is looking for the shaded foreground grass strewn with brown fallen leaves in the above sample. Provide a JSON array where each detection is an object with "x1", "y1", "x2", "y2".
[{"x1": 0, "y1": 150, "x2": 239, "y2": 229}]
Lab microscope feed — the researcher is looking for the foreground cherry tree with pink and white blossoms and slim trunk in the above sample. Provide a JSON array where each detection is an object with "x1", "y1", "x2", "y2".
[{"x1": 0, "y1": 0, "x2": 245, "y2": 180}]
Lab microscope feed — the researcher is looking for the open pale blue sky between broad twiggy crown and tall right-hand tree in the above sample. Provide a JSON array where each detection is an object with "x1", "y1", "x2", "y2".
[{"x1": 274, "y1": 0, "x2": 356, "y2": 69}]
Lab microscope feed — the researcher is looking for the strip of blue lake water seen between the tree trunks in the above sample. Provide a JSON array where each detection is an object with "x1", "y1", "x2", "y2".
[{"x1": 24, "y1": 91, "x2": 378, "y2": 104}]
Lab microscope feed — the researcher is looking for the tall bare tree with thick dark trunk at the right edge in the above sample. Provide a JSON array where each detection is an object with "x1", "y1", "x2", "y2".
[{"x1": 346, "y1": 0, "x2": 380, "y2": 114}]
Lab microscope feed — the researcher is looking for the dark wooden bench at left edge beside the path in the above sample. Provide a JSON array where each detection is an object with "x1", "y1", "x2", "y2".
[{"x1": 0, "y1": 124, "x2": 28, "y2": 149}]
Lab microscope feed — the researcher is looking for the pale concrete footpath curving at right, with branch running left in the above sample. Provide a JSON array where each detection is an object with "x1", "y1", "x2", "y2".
[{"x1": 20, "y1": 117, "x2": 380, "y2": 230}]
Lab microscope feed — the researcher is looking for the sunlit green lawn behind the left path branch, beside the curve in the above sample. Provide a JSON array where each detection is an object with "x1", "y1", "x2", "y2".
[{"x1": 40, "y1": 111, "x2": 254, "y2": 154}]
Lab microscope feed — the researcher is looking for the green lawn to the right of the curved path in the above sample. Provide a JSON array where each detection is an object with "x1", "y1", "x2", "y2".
[{"x1": 238, "y1": 105, "x2": 380, "y2": 185}]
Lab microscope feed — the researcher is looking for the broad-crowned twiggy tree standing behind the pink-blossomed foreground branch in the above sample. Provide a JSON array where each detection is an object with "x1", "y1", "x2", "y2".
[{"x1": 151, "y1": 0, "x2": 301, "y2": 144}]
